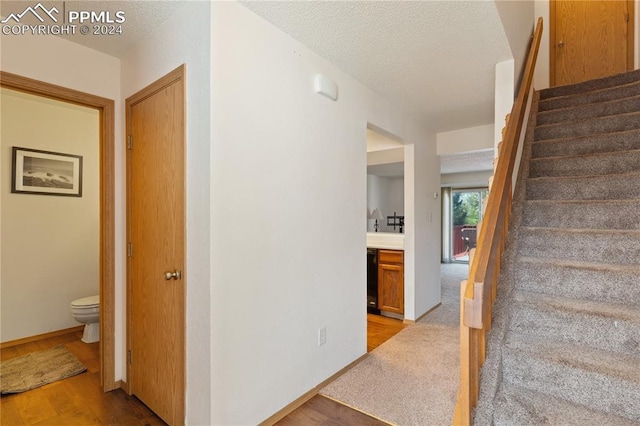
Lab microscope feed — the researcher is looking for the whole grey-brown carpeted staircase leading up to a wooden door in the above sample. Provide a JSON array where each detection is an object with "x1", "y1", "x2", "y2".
[{"x1": 474, "y1": 71, "x2": 640, "y2": 426}]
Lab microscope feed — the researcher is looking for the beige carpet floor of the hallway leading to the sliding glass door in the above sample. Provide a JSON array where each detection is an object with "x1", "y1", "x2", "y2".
[{"x1": 320, "y1": 264, "x2": 469, "y2": 426}]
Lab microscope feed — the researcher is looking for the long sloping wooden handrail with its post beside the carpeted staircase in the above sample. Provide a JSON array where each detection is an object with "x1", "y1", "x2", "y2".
[{"x1": 453, "y1": 18, "x2": 542, "y2": 425}]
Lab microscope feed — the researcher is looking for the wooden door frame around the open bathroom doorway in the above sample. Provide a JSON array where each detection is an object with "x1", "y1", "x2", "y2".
[{"x1": 0, "y1": 71, "x2": 121, "y2": 392}]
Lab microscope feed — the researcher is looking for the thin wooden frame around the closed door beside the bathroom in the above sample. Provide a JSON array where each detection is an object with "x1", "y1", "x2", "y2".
[{"x1": 125, "y1": 64, "x2": 188, "y2": 421}]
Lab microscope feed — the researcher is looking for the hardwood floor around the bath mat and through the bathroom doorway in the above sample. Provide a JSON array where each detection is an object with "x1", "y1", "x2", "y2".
[{"x1": 0, "y1": 332, "x2": 165, "y2": 426}]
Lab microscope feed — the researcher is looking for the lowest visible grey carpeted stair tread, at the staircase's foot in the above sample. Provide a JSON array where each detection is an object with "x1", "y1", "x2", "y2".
[{"x1": 496, "y1": 383, "x2": 638, "y2": 426}]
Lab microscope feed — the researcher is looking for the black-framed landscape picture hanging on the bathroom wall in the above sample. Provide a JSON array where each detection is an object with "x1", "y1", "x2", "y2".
[{"x1": 11, "y1": 146, "x2": 82, "y2": 197}]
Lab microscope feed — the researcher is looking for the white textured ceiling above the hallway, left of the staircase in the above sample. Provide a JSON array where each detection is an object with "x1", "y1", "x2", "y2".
[{"x1": 242, "y1": 0, "x2": 512, "y2": 131}]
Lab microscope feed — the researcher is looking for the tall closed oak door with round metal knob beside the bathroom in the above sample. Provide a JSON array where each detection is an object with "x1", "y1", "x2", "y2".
[{"x1": 127, "y1": 67, "x2": 185, "y2": 425}]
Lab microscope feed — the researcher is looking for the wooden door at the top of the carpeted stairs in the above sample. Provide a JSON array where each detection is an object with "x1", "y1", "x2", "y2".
[{"x1": 550, "y1": 0, "x2": 634, "y2": 86}]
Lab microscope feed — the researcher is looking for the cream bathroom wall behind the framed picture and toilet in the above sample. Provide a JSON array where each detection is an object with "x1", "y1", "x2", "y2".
[{"x1": 0, "y1": 88, "x2": 100, "y2": 342}]
